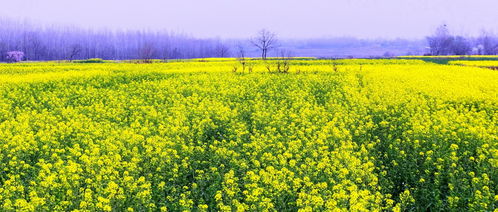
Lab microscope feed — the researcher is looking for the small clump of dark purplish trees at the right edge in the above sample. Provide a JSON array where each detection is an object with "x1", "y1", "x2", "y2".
[{"x1": 427, "y1": 25, "x2": 498, "y2": 55}]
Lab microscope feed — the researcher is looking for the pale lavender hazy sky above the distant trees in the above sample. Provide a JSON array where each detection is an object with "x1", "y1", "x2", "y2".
[{"x1": 0, "y1": 0, "x2": 498, "y2": 38}]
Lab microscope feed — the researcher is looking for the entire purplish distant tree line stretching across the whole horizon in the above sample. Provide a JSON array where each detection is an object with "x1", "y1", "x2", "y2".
[{"x1": 0, "y1": 19, "x2": 498, "y2": 62}]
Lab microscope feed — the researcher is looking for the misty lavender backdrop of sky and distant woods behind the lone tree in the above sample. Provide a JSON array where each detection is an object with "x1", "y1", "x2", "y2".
[{"x1": 0, "y1": 0, "x2": 498, "y2": 60}]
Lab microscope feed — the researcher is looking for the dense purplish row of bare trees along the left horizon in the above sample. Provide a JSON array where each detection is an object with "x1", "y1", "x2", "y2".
[{"x1": 0, "y1": 19, "x2": 230, "y2": 61}]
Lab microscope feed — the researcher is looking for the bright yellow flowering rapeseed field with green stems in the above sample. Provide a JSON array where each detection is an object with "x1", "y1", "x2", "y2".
[{"x1": 0, "y1": 58, "x2": 498, "y2": 211}]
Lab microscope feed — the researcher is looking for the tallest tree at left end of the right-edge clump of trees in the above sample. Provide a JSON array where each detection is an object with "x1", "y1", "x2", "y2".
[{"x1": 427, "y1": 24, "x2": 454, "y2": 55}]
